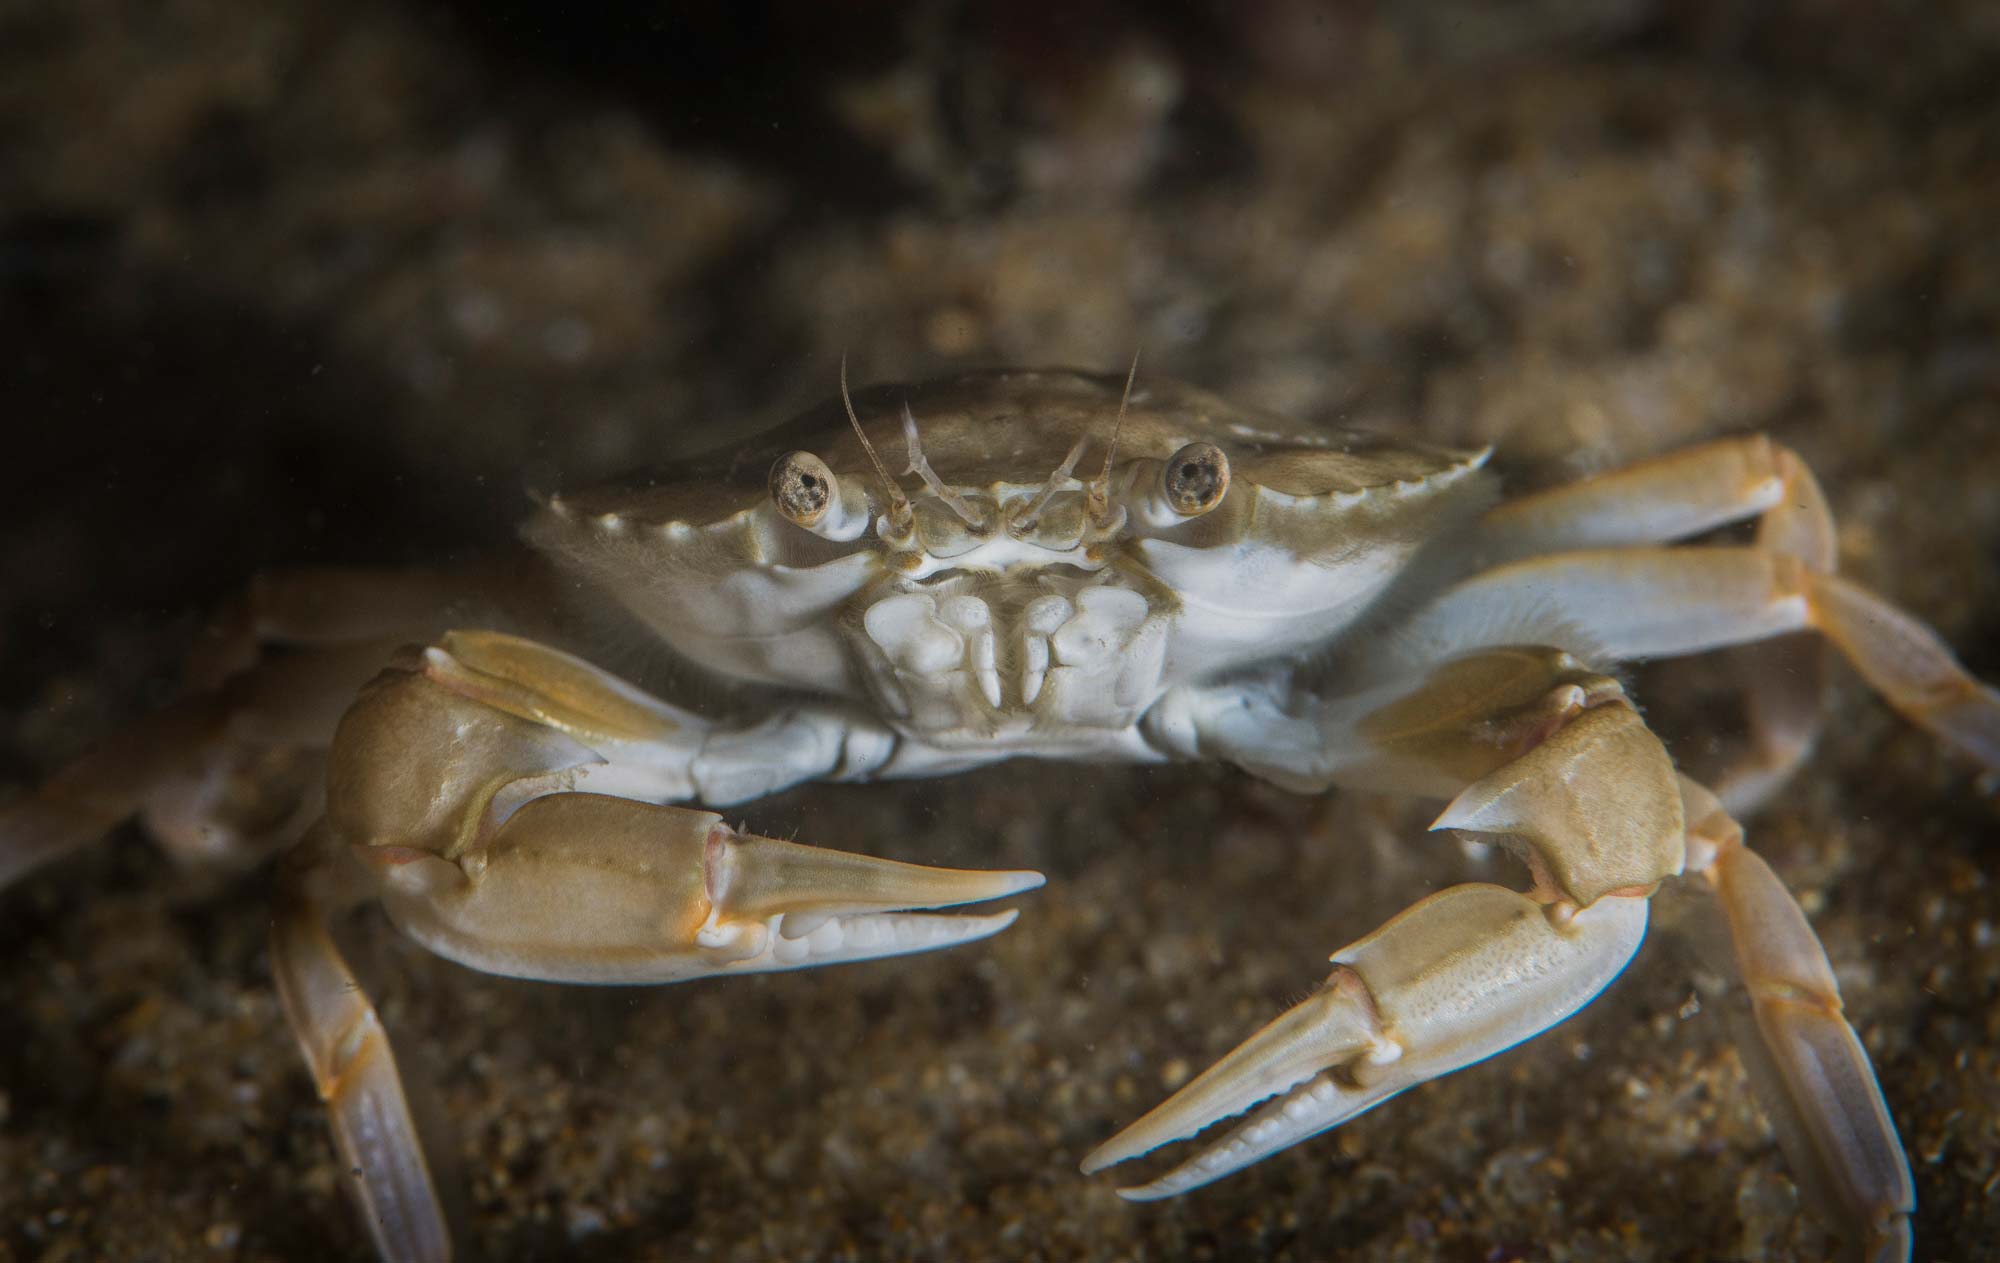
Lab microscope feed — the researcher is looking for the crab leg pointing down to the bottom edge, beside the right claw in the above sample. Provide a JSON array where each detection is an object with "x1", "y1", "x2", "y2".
[{"x1": 1680, "y1": 777, "x2": 1916, "y2": 1263}]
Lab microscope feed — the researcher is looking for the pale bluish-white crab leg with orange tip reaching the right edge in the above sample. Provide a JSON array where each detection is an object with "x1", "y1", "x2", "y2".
[{"x1": 1408, "y1": 548, "x2": 2000, "y2": 767}]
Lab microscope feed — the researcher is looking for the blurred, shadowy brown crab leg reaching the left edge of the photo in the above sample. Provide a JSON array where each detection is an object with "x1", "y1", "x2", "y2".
[{"x1": 0, "y1": 643, "x2": 394, "y2": 889}]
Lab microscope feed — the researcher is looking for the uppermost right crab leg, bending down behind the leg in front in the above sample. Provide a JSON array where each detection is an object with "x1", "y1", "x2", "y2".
[{"x1": 1480, "y1": 434, "x2": 1836, "y2": 813}]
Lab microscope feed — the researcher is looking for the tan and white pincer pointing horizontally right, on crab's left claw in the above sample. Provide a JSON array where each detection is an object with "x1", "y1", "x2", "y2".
[{"x1": 354, "y1": 793, "x2": 1042, "y2": 983}]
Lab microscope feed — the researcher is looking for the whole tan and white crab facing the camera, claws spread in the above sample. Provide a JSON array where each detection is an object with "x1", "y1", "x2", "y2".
[{"x1": 0, "y1": 364, "x2": 2000, "y2": 1261}]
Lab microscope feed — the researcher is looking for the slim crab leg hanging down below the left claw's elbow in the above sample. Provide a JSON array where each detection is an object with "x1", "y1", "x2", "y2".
[{"x1": 270, "y1": 831, "x2": 452, "y2": 1263}]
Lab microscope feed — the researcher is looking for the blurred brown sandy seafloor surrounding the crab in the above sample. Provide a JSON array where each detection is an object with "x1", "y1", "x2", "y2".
[{"x1": 0, "y1": 0, "x2": 2000, "y2": 1263}]
